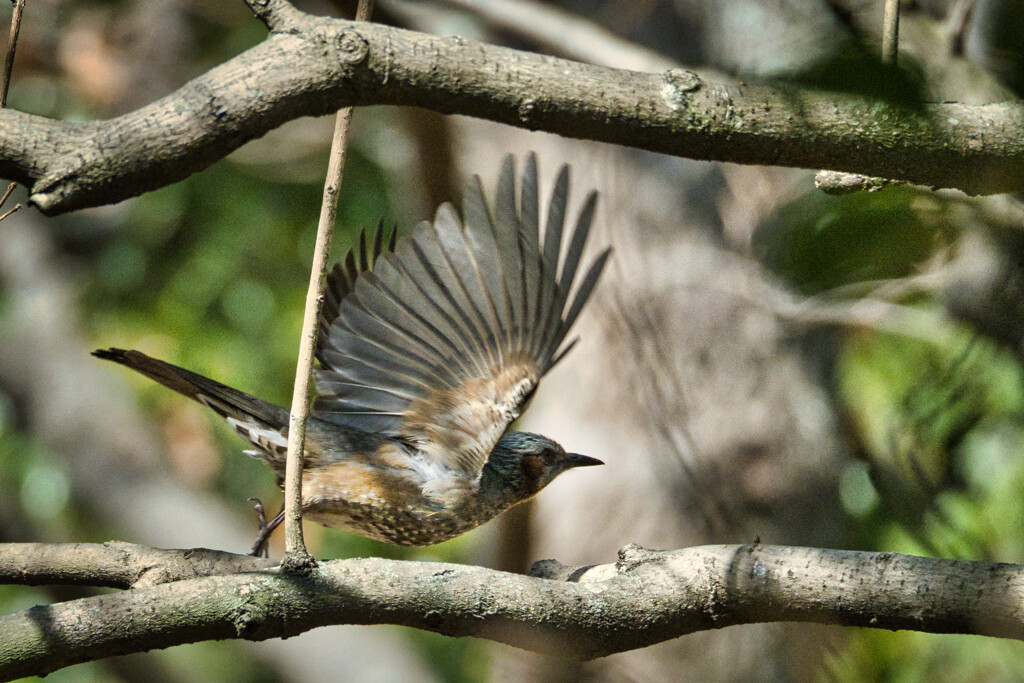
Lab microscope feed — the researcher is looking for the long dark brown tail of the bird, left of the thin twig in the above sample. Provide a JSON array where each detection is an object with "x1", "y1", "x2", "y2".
[{"x1": 92, "y1": 348, "x2": 288, "y2": 465}]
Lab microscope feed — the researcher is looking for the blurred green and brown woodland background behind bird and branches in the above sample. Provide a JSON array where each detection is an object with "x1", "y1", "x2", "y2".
[{"x1": 6, "y1": 0, "x2": 1024, "y2": 682}]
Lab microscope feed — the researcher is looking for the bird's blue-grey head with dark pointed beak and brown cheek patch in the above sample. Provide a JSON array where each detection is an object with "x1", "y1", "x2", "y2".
[{"x1": 480, "y1": 432, "x2": 604, "y2": 503}]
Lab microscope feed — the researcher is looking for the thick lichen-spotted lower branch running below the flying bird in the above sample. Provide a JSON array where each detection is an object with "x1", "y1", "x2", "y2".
[{"x1": 0, "y1": 544, "x2": 1024, "y2": 680}]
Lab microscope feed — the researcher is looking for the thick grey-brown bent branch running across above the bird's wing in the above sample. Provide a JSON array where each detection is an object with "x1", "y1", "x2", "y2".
[{"x1": 0, "y1": 0, "x2": 1024, "y2": 215}]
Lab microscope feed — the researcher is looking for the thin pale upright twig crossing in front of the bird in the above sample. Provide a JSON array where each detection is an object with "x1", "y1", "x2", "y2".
[{"x1": 282, "y1": 0, "x2": 373, "y2": 569}]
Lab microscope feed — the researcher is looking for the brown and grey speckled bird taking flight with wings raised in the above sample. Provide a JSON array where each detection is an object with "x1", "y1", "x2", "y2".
[{"x1": 93, "y1": 154, "x2": 611, "y2": 555}]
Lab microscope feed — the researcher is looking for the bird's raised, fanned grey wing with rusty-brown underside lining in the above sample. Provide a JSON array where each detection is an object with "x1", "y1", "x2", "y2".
[{"x1": 313, "y1": 155, "x2": 610, "y2": 476}]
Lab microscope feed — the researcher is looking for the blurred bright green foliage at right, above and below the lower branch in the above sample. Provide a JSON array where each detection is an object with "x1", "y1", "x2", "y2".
[{"x1": 828, "y1": 330, "x2": 1024, "y2": 681}]
